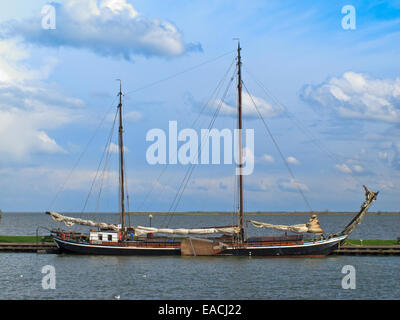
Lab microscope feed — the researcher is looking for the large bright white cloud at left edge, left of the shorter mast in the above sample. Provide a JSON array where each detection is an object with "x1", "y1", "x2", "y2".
[{"x1": 0, "y1": 41, "x2": 83, "y2": 162}]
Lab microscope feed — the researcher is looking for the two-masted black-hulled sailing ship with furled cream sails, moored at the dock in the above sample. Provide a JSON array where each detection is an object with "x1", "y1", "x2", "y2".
[{"x1": 46, "y1": 42, "x2": 379, "y2": 257}]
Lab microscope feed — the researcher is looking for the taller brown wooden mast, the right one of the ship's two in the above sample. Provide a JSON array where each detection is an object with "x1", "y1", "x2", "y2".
[{"x1": 237, "y1": 39, "x2": 244, "y2": 241}]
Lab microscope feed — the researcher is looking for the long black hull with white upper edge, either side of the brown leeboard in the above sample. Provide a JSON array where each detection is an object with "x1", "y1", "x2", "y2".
[{"x1": 54, "y1": 236, "x2": 346, "y2": 257}]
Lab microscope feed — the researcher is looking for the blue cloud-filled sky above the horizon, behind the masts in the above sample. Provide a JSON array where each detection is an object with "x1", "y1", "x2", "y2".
[{"x1": 0, "y1": 0, "x2": 400, "y2": 212}]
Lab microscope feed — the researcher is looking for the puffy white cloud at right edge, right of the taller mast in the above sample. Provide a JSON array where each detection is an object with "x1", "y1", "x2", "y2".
[{"x1": 301, "y1": 72, "x2": 400, "y2": 123}]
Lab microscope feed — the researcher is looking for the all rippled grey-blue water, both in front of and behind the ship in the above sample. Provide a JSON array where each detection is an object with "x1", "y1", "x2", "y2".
[{"x1": 0, "y1": 213, "x2": 400, "y2": 300}]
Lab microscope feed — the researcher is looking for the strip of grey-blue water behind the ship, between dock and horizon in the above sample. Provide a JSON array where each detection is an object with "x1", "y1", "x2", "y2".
[{"x1": 0, "y1": 212, "x2": 400, "y2": 239}]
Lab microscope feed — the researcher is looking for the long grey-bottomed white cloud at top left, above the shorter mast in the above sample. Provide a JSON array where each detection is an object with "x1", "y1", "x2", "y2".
[{"x1": 3, "y1": 0, "x2": 201, "y2": 60}]
